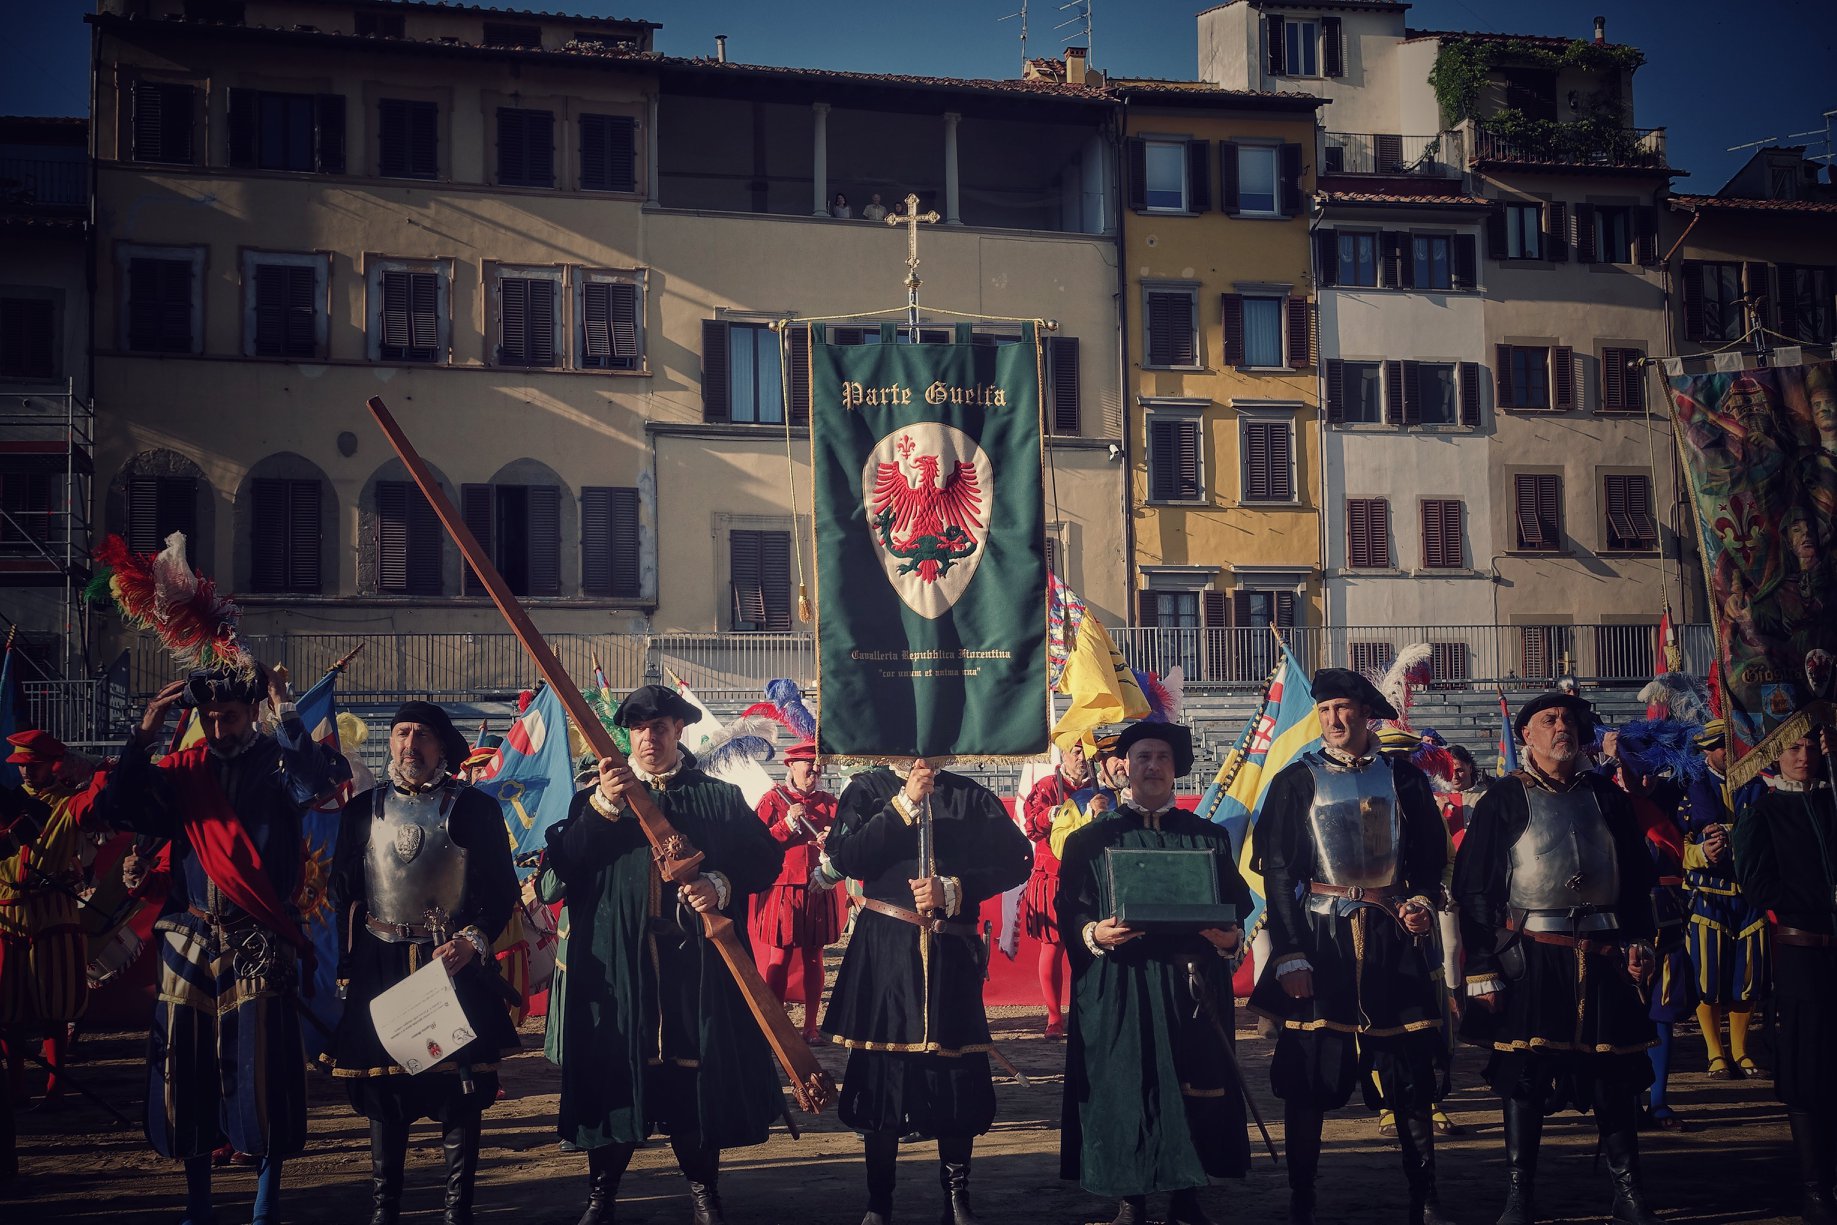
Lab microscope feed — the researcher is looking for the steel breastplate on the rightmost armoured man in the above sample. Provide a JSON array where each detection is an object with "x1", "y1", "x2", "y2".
[{"x1": 1506, "y1": 784, "x2": 1620, "y2": 918}]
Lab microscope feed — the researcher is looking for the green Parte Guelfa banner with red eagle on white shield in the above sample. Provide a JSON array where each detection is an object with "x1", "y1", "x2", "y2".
[{"x1": 810, "y1": 323, "x2": 1047, "y2": 759}]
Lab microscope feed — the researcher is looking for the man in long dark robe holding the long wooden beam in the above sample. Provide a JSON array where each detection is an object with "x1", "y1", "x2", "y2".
[{"x1": 544, "y1": 685, "x2": 784, "y2": 1225}]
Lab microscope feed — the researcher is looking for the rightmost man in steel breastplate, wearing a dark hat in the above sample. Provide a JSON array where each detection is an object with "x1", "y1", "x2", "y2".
[{"x1": 1453, "y1": 692, "x2": 1659, "y2": 1225}]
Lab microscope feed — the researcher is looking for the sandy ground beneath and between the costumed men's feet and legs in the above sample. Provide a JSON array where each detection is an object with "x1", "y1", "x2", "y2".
[{"x1": 0, "y1": 1008, "x2": 1798, "y2": 1225}]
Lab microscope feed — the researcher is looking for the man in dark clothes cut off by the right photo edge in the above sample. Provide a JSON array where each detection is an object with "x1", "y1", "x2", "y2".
[{"x1": 1732, "y1": 727, "x2": 1837, "y2": 1225}]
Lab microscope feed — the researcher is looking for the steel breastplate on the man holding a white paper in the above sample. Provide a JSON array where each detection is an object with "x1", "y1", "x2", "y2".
[{"x1": 364, "y1": 782, "x2": 467, "y2": 926}]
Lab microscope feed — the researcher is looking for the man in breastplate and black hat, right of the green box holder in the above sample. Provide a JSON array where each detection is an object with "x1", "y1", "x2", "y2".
[{"x1": 1251, "y1": 669, "x2": 1448, "y2": 1225}]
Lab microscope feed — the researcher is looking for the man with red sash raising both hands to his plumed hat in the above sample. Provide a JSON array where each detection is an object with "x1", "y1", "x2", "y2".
[{"x1": 96, "y1": 665, "x2": 351, "y2": 1225}]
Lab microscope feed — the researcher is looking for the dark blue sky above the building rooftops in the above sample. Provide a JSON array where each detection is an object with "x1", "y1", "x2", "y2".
[{"x1": 0, "y1": 0, "x2": 1837, "y2": 191}]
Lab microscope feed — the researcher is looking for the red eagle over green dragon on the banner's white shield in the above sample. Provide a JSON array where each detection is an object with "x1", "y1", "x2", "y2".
[{"x1": 867, "y1": 433, "x2": 983, "y2": 582}]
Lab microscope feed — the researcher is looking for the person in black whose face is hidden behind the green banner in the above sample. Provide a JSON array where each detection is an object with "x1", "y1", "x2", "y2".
[{"x1": 823, "y1": 759, "x2": 1032, "y2": 1225}]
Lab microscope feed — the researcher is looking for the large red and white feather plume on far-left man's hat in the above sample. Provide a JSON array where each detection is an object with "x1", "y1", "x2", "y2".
[{"x1": 96, "y1": 533, "x2": 255, "y2": 669}]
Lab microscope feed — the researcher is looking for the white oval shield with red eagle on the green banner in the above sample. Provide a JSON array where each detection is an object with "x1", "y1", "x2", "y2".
[{"x1": 862, "y1": 421, "x2": 996, "y2": 621}]
